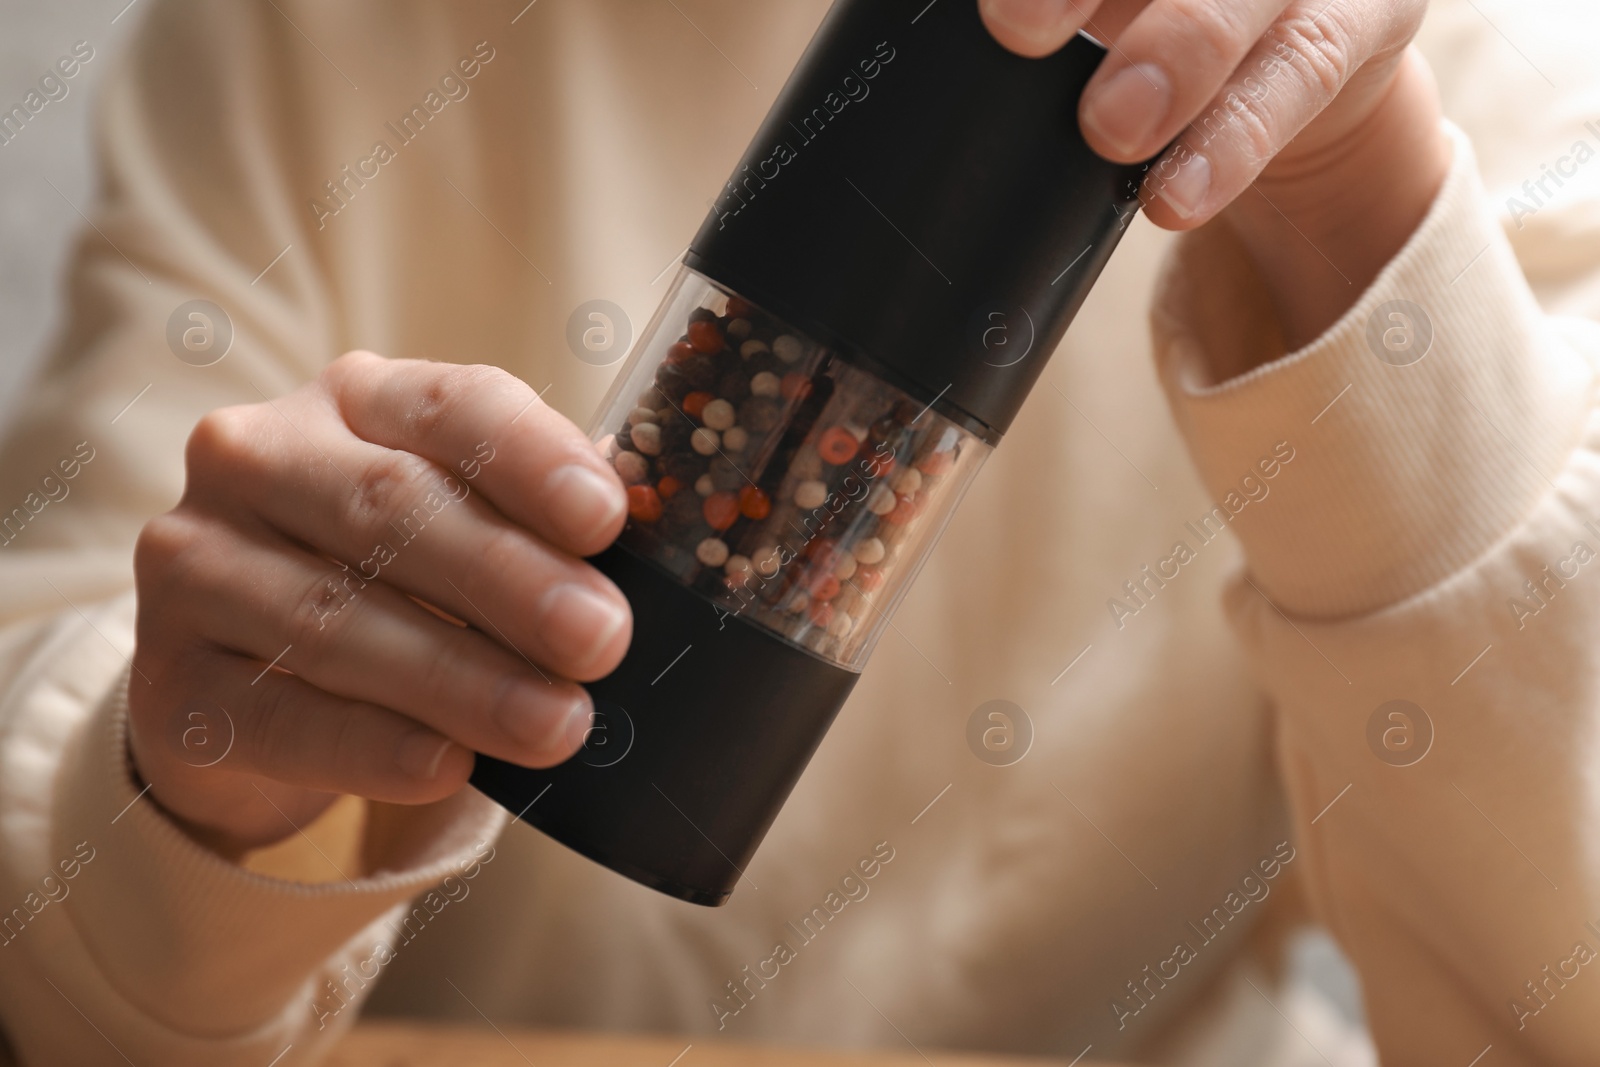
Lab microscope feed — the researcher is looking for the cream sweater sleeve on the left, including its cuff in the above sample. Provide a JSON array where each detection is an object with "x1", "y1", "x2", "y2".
[{"x1": 0, "y1": 2, "x2": 506, "y2": 1067}]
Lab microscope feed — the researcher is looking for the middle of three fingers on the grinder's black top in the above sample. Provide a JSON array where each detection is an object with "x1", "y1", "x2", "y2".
[{"x1": 1078, "y1": 0, "x2": 1288, "y2": 163}]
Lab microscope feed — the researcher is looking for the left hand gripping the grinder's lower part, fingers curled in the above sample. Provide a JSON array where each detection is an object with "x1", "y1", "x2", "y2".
[{"x1": 128, "y1": 352, "x2": 632, "y2": 854}]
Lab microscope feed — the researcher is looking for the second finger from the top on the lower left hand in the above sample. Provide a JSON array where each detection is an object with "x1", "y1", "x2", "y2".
[{"x1": 190, "y1": 396, "x2": 630, "y2": 680}]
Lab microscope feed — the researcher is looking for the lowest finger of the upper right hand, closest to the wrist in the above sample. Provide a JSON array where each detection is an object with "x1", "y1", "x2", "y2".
[{"x1": 1141, "y1": 0, "x2": 1386, "y2": 229}]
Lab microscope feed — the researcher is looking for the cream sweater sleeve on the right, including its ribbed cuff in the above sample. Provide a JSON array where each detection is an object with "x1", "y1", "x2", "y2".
[{"x1": 1154, "y1": 120, "x2": 1600, "y2": 1065}]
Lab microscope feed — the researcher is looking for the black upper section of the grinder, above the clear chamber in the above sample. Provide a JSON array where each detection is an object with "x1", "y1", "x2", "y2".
[{"x1": 685, "y1": 0, "x2": 1147, "y2": 437}]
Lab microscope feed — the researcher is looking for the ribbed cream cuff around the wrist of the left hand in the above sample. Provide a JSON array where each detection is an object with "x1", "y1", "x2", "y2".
[{"x1": 54, "y1": 672, "x2": 507, "y2": 1037}]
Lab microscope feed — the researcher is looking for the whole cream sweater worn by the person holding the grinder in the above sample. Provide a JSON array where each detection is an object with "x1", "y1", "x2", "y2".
[{"x1": 0, "y1": 0, "x2": 1600, "y2": 1067}]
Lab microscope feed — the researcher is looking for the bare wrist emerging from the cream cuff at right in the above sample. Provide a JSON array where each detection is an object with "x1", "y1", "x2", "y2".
[{"x1": 1213, "y1": 53, "x2": 1451, "y2": 363}]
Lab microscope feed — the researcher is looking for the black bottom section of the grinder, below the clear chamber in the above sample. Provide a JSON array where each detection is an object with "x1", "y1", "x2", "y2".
[{"x1": 472, "y1": 547, "x2": 859, "y2": 907}]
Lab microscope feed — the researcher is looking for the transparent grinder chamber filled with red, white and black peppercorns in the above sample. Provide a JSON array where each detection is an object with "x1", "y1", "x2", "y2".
[{"x1": 594, "y1": 267, "x2": 990, "y2": 670}]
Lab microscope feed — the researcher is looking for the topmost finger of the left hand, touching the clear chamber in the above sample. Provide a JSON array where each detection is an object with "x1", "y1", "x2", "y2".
[{"x1": 325, "y1": 352, "x2": 627, "y2": 555}]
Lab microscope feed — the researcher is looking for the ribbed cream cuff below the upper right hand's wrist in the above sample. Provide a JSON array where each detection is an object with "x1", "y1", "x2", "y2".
[{"x1": 1152, "y1": 123, "x2": 1594, "y2": 617}]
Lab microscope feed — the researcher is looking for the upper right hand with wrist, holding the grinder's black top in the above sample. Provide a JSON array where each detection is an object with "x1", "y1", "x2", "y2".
[{"x1": 981, "y1": 0, "x2": 1450, "y2": 355}]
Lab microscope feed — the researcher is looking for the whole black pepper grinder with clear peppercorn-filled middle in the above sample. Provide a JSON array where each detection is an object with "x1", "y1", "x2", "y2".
[{"x1": 472, "y1": 0, "x2": 1147, "y2": 905}]
